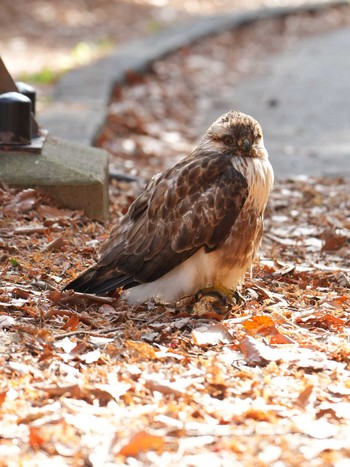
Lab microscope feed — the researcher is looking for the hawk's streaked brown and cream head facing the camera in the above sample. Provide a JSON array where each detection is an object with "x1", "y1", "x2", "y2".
[{"x1": 200, "y1": 110, "x2": 267, "y2": 159}]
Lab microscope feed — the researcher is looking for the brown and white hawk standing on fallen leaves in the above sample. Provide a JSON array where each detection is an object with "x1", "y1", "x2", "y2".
[{"x1": 65, "y1": 111, "x2": 274, "y2": 304}]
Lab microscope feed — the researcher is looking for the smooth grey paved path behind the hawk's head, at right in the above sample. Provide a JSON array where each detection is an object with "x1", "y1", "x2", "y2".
[{"x1": 203, "y1": 28, "x2": 350, "y2": 178}]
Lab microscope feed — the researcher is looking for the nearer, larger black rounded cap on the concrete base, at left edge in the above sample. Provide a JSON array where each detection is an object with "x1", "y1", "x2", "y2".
[{"x1": 0, "y1": 92, "x2": 32, "y2": 145}]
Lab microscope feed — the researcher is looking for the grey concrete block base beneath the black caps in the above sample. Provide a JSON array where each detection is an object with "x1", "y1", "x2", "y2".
[{"x1": 0, "y1": 136, "x2": 108, "y2": 220}]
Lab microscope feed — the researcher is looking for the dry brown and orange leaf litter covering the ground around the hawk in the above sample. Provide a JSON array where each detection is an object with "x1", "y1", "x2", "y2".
[{"x1": 0, "y1": 6, "x2": 350, "y2": 466}]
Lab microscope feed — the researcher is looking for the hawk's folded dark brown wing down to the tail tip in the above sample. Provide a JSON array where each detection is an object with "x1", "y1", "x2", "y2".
[{"x1": 66, "y1": 152, "x2": 248, "y2": 293}]
